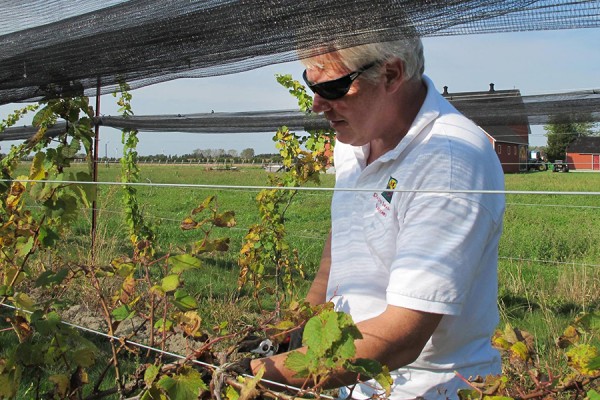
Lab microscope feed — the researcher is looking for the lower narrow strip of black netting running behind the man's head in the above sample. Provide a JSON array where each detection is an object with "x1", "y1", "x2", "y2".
[{"x1": 0, "y1": 89, "x2": 600, "y2": 143}]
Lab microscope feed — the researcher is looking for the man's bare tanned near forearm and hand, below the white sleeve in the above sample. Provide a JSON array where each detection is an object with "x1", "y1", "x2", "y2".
[{"x1": 251, "y1": 306, "x2": 442, "y2": 388}]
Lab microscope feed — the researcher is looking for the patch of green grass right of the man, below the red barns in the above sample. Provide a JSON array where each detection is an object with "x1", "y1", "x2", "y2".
[{"x1": 499, "y1": 172, "x2": 600, "y2": 354}]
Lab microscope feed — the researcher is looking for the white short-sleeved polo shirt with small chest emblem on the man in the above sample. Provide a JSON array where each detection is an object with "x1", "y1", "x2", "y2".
[{"x1": 327, "y1": 78, "x2": 504, "y2": 399}]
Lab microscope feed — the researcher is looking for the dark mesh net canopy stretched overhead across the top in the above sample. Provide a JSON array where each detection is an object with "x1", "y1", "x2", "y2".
[{"x1": 0, "y1": 0, "x2": 600, "y2": 104}]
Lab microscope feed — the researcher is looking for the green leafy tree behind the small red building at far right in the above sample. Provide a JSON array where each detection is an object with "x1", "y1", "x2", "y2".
[{"x1": 544, "y1": 122, "x2": 600, "y2": 161}]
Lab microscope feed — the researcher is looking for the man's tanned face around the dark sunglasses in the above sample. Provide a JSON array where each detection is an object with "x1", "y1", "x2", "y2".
[{"x1": 306, "y1": 58, "x2": 383, "y2": 146}]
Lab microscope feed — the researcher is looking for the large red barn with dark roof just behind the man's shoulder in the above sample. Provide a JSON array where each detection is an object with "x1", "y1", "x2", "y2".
[{"x1": 442, "y1": 83, "x2": 531, "y2": 173}]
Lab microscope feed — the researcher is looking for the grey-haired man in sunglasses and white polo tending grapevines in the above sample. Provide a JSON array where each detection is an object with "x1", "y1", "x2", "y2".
[{"x1": 246, "y1": 38, "x2": 504, "y2": 399}]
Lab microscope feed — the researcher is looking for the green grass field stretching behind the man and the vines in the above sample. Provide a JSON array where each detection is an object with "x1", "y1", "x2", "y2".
[{"x1": 5, "y1": 165, "x2": 600, "y2": 396}]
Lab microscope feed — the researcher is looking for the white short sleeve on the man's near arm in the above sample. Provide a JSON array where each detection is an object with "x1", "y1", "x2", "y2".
[{"x1": 387, "y1": 193, "x2": 498, "y2": 315}]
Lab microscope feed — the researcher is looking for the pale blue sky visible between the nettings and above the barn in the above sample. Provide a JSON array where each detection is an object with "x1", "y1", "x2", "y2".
[{"x1": 0, "y1": 29, "x2": 600, "y2": 157}]
